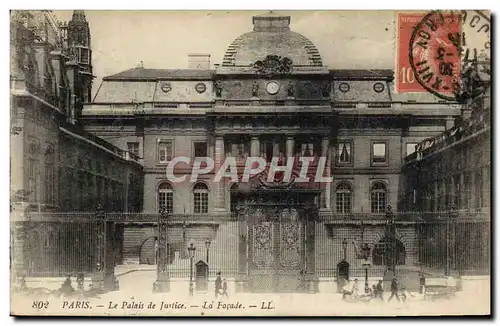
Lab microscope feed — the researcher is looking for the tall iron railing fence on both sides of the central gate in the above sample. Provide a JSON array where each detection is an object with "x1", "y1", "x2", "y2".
[{"x1": 13, "y1": 212, "x2": 491, "y2": 278}]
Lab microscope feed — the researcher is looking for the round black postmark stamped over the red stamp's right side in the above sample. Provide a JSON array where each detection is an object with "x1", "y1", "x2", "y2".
[{"x1": 409, "y1": 11, "x2": 489, "y2": 103}]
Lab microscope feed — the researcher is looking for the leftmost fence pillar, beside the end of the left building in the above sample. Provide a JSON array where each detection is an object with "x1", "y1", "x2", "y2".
[{"x1": 92, "y1": 207, "x2": 119, "y2": 291}]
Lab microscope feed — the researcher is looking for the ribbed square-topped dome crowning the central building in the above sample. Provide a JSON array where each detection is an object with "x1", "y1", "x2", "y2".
[{"x1": 222, "y1": 14, "x2": 323, "y2": 67}]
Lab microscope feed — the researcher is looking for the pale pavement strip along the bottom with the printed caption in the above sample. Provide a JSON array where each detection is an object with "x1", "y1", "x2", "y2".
[{"x1": 11, "y1": 268, "x2": 490, "y2": 316}]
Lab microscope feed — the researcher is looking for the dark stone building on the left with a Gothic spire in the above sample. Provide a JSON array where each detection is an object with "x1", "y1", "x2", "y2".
[{"x1": 10, "y1": 10, "x2": 143, "y2": 275}]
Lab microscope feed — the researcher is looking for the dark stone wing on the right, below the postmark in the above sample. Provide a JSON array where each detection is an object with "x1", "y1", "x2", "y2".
[{"x1": 398, "y1": 84, "x2": 492, "y2": 273}]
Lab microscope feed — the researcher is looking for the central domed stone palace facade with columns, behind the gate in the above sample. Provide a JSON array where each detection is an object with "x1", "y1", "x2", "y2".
[{"x1": 81, "y1": 14, "x2": 470, "y2": 291}]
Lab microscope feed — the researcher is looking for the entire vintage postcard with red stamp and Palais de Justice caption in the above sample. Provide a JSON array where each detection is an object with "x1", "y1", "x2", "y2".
[{"x1": 9, "y1": 10, "x2": 493, "y2": 317}]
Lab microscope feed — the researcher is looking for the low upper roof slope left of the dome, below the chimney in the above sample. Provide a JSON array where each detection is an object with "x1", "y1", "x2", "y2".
[{"x1": 103, "y1": 68, "x2": 215, "y2": 80}]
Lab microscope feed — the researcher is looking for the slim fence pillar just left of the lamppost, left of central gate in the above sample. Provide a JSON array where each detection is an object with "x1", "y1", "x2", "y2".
[{"x1": 153, "y1": 208, "x2": 170, "y2": 292}]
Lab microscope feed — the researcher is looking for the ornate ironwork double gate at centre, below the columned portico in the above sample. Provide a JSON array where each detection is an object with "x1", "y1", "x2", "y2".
[{"x1": 233, "y1": 189, "x2": 317, "y2": 292}]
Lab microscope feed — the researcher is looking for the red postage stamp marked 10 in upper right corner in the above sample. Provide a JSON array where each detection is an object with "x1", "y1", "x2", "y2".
[{"x1": 396, "y1": 12, "x2": 461, "y2": 98}]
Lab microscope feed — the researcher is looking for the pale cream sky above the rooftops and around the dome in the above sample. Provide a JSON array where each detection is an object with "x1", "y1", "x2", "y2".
[{"x1": 54, "y1": 10, "x2": 396, "y2": 94}]
